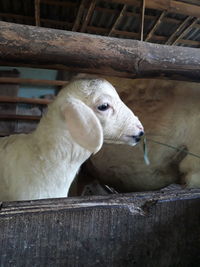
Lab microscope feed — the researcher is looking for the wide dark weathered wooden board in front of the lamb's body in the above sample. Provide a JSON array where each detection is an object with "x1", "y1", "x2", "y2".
[{"x1": 0, "y1": 190, "x2": 200, "y2": 267}]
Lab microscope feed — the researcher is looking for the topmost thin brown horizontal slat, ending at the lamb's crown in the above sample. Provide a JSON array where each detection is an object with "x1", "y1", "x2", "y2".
[{"x1": 0, "y1": 77, "x2": 68, "y2": 86}]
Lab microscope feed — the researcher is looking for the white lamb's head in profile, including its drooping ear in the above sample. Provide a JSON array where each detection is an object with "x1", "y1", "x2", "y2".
[{"x1": 57, "y1": 79, "x2": 144, "y2": 153}]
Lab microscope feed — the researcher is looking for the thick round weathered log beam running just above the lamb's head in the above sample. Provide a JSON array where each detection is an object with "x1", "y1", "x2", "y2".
[{"x1": 0, "y1": 22, "x2": 200, "y2": 81}]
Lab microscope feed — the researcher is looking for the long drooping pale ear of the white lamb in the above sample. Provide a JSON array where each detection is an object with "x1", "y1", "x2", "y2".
[{"x1": 61, "y1": 98, "x2": 103, "y2": 153}]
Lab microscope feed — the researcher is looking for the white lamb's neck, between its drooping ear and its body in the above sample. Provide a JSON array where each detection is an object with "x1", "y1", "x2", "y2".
[{"x1": 33, "y1": 111, "x2": 91, "y2": 167}]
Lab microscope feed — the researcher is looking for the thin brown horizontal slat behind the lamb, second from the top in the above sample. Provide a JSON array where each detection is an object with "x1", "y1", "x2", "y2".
[{"x1": 0, "y1": 96, "x2": 52, "y2": 105}]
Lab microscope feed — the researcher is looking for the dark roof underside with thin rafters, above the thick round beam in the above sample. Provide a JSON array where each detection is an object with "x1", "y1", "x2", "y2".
[{"x1": 0, "y1": 0, "x2": 200, "y2": 47}]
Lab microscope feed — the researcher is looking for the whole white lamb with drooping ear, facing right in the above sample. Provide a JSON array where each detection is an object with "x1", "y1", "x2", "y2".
[{"x1": 0, "y1": 79, "x2": 144, "y2": 201}]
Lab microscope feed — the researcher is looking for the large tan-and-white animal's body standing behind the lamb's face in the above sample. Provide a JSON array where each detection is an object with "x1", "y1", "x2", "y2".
[{"x1": 91, "y1": 77, "x2": 200, "y2": 192}]
